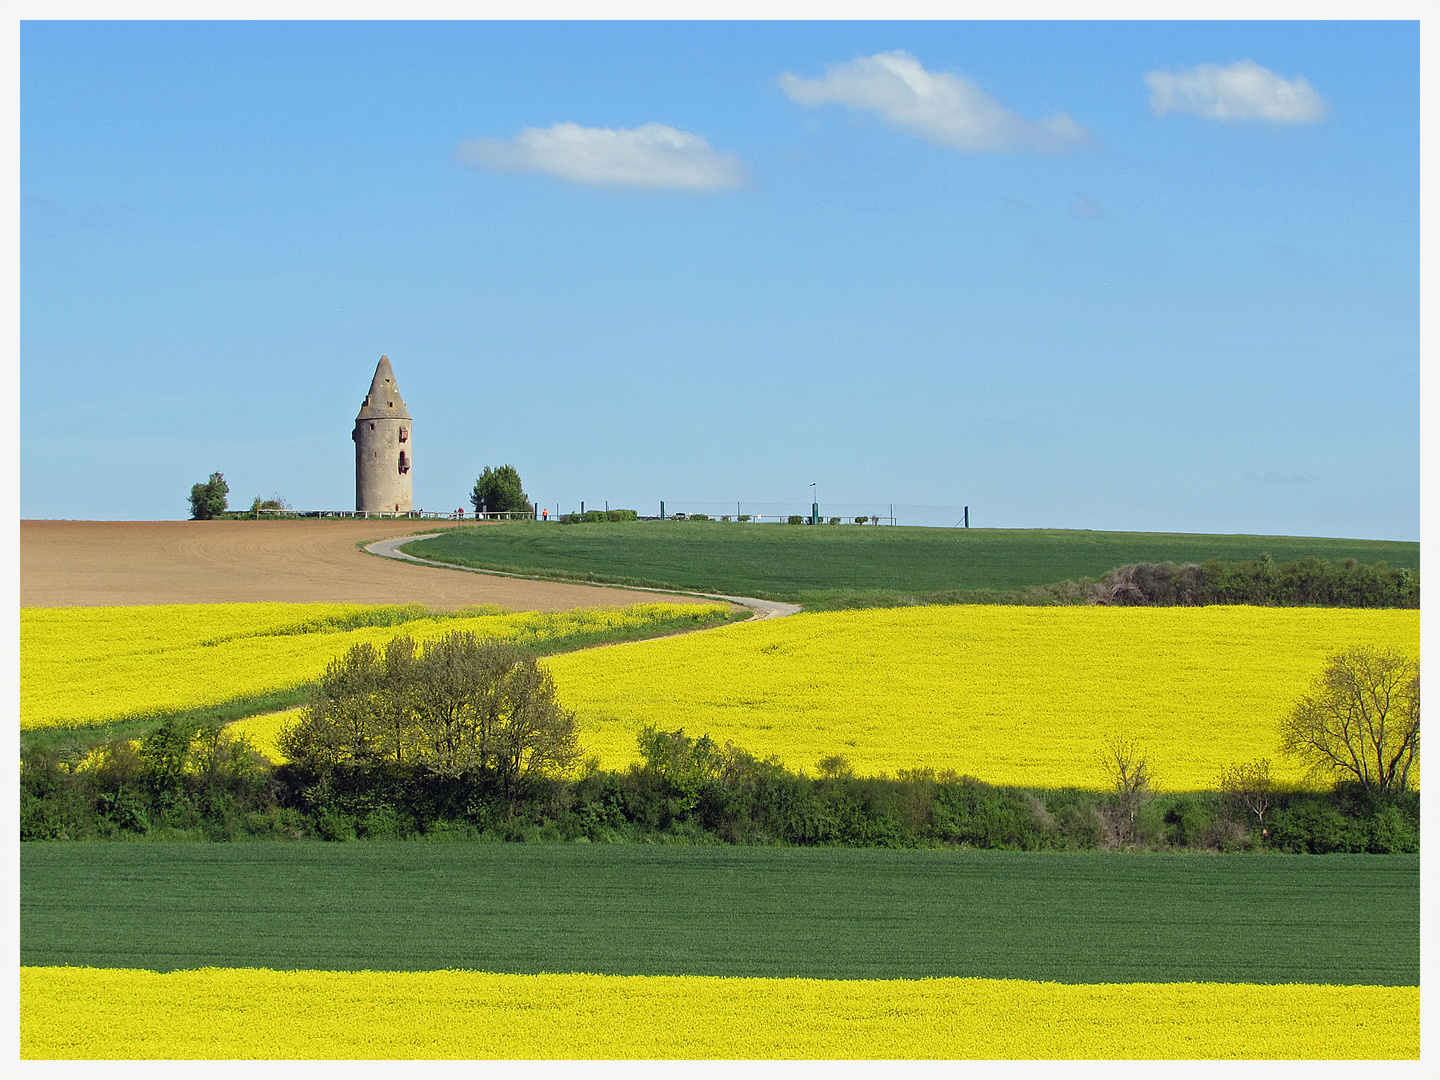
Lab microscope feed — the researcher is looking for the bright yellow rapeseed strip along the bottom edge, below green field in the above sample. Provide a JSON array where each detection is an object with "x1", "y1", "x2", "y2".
[{"x1": 20, "y1": 968, "x2": 1420, "y2": 1058}]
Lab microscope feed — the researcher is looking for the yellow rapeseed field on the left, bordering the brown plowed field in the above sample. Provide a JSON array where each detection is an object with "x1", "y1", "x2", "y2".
[{"x1": 20, "y1": 603, "x2": 726, "y2": 729}]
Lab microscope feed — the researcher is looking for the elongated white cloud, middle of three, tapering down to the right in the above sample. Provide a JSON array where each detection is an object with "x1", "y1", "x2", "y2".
[{"x1": 780, "y1": 50, "x2": 1092, "y2": 153}]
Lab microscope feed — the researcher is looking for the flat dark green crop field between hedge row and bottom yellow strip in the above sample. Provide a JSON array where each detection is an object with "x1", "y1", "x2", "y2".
[{"x1": 20, "y1": 842, "x2": 1420, "y2": 986}]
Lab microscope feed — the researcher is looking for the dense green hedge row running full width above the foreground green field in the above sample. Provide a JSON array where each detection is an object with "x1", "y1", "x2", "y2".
[{"x1": 20, "y1": 720, "x2": 1420, "y2": 854}]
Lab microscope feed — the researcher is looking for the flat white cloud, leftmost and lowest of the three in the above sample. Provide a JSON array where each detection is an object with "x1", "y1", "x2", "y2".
[{"x1": 455, "y1": 124, "x2": 744, "y2": 192}]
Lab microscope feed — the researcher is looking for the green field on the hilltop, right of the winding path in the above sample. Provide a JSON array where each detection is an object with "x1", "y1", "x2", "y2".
[{"x1": 405, "y1": 521, "x2": 1420, "y2": 599}]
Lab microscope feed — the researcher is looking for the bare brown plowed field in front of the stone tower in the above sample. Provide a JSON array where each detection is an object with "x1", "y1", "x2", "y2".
[{"x1": 20, "y1": 520, "x2": 717, "y2": 611}]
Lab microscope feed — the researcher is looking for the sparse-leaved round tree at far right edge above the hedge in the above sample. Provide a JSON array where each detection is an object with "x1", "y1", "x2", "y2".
[{"x1": 1280, "y1": 647, "x2": 1420, "y2": 796}]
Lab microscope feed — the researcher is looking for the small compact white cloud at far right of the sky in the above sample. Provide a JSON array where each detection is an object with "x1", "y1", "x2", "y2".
[{"x1": 1145, "y1": 60, "x2": 1329, "y2": 124}]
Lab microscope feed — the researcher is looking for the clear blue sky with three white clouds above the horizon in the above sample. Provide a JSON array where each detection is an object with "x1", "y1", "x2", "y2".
[{"x1": 20, "y1": 22, "x2": 1420, "y2": 540}]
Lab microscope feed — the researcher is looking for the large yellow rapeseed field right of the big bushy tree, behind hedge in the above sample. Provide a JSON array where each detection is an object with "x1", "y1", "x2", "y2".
[{"x1": 546, "y1": 606, "x2": 1420, "y2": 791}]
